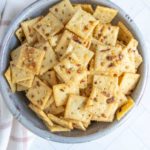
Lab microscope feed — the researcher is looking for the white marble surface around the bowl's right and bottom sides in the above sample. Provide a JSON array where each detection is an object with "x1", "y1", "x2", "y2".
[{"x1": 1, "y1": 0, "x2": 150, "y2": 150}]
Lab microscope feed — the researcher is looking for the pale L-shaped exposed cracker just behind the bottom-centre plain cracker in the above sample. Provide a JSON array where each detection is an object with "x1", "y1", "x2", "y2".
[{"x1": 53, "y1": 83, "x2": 79, "y2": 106}]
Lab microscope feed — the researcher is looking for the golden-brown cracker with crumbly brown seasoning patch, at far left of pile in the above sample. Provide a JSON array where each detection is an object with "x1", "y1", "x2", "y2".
[{"x1": 16, "y1": 45, "x2": 45, "y2": 75}]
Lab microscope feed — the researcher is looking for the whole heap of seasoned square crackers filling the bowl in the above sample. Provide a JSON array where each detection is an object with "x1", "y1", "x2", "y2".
[{"x1": 5, "y1": 0, "x2": 142, "y2": 132}]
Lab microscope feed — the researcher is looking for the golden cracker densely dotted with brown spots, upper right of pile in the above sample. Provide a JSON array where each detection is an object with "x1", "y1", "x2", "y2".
[{"x1": 94, "y1": 24, "x2": 119, "y2": 46}]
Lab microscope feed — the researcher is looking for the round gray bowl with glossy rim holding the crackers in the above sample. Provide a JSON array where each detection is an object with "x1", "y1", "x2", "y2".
[{"x1": 0, "y1": 0, "x2": 148, "y2": 143}]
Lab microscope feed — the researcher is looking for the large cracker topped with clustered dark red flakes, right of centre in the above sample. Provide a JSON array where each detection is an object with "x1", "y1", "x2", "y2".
[{"x1": 94, "y1": 45, "x2": 125, "y2": 76}]
